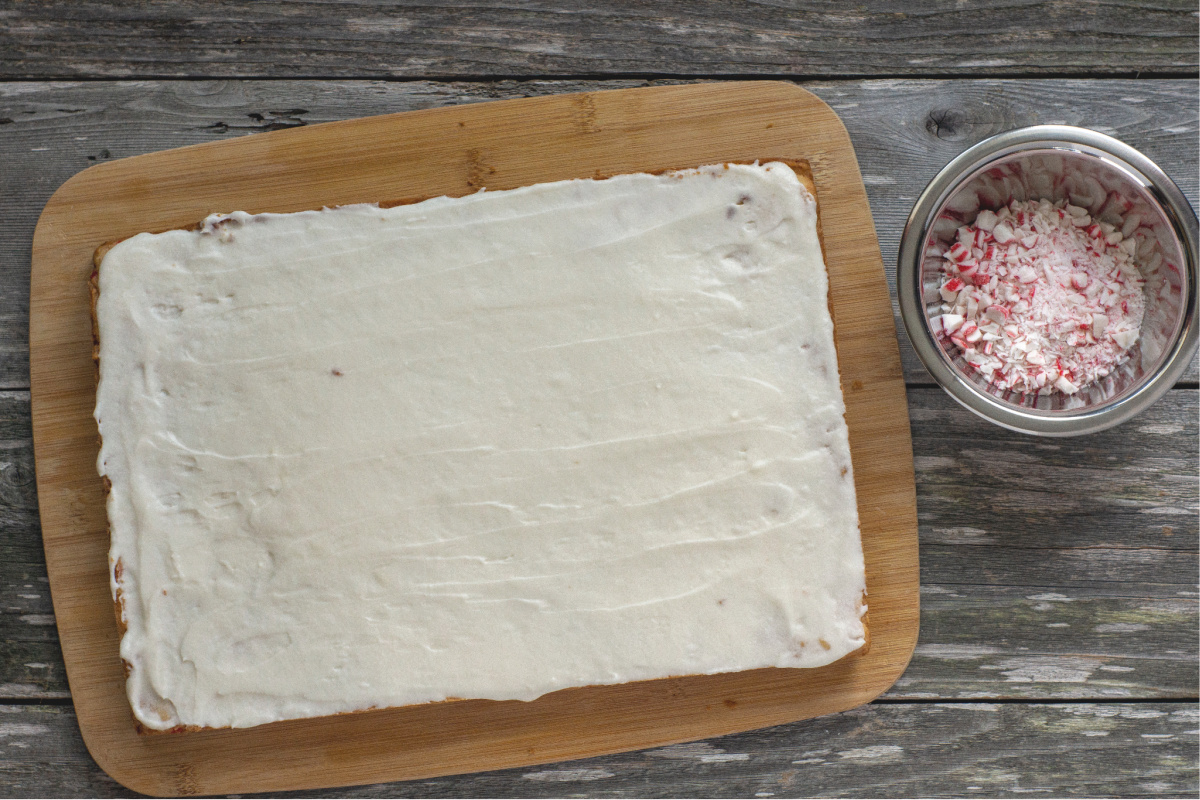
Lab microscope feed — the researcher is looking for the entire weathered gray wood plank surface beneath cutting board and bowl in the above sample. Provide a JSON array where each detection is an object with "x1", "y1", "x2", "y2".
[{"x1": 0, "y1": 0, "x2": 1200, "y2": 798}]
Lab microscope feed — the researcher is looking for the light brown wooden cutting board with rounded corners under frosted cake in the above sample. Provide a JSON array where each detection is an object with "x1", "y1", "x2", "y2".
[{"x1": 29, "y1": 82, "x2": 918, "y2": 795}]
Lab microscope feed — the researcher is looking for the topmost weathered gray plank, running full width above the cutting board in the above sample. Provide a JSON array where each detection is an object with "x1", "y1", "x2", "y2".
[{"x1": 0, "y1": 0, "x2": 1196, "y2": 78}]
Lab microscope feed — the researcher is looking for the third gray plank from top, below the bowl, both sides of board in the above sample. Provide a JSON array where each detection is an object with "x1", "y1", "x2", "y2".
[{"x1": 0, "y1": 389, "x2": 1200, "y2": 700}]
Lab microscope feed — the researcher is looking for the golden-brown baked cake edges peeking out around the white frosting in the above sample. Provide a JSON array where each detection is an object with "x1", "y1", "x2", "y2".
[{"x1": 88, "y1": 158, "x2": 871, "y2": 735}]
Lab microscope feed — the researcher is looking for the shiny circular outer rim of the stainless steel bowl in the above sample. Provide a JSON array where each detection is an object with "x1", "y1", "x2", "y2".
[{"x1": 896, "y1": 125, "x2": 1200, "y2": 437}]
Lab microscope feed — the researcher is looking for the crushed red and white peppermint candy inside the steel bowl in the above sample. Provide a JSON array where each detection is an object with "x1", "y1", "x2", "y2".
[{"x1": 930, "y1": 200, "x2": 1145, "y2": 395}]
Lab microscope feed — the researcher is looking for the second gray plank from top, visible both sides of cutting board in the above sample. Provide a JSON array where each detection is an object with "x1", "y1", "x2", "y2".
[{"x1": 0, "y1": 80, "x2": 1200, "y2": 389}]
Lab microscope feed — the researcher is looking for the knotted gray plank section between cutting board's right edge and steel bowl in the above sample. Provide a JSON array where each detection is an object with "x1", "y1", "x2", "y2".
[{"x1": 840, "y1": 80, "x2": 1200, "y2": 384}]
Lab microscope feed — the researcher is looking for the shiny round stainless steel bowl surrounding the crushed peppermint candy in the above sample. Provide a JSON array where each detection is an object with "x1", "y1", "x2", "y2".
[{"x1": 896, "y1": 125, "x2": 1200, "y2": 437}]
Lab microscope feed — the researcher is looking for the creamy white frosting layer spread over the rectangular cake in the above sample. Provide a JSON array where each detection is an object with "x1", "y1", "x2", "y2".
[{"x1": 96, "y1": 164, "x2": 865, "y2": 728}]
